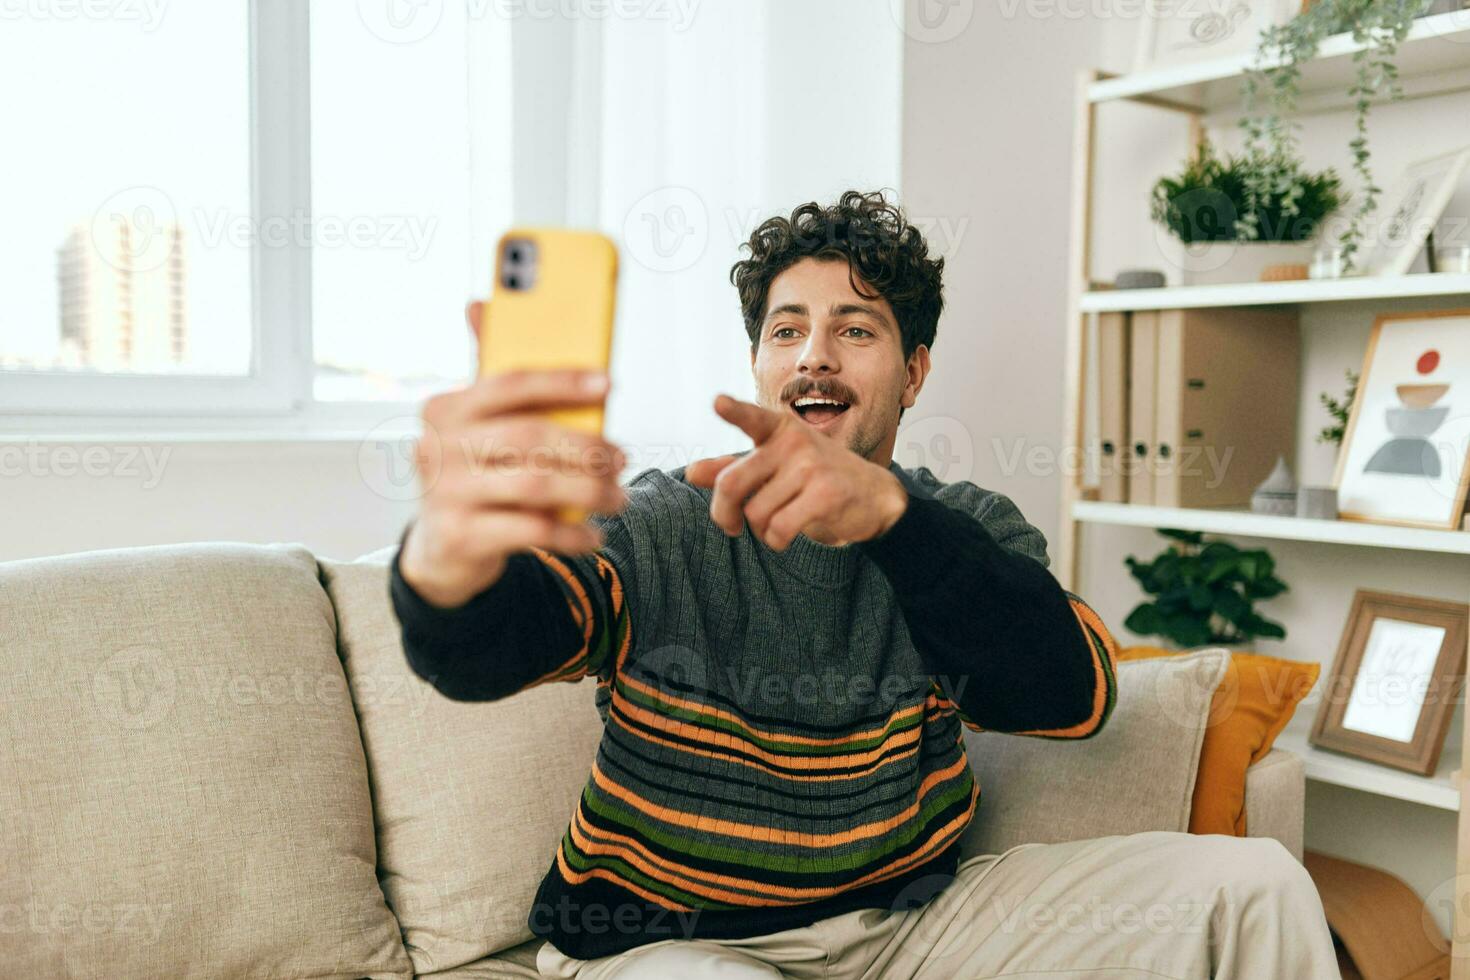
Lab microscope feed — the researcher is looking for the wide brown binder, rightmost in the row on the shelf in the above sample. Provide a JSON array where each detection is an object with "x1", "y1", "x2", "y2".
[{"x1": 1152, "y1": 307, "x2": 1301, "y2": 507}]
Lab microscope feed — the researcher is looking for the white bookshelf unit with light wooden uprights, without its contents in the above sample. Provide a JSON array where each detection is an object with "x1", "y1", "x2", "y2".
[{"x1": 1054, "y1": 19, "x2": 1470, "y2": 980}]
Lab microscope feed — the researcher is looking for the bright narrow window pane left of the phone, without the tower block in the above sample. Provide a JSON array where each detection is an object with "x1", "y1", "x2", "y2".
[{"x1": 310, "y1": 0, "x2": 476, "y2": 401}]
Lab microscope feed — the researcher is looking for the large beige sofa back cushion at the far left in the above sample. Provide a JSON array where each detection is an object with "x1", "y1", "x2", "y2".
[{"x1": 0, "y1": 545, "x2": 410, "y2": 980}]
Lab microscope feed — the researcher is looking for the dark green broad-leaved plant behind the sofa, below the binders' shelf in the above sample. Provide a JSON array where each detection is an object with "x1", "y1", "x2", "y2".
[{"x1": 1123, "y1": 527, "x2": 1286, "y2": 649}]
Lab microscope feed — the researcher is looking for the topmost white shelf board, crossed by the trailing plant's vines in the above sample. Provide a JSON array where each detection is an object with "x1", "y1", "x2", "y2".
[{"x1": 1088, "y1": 10, "x2": 1470, "y2": 112}]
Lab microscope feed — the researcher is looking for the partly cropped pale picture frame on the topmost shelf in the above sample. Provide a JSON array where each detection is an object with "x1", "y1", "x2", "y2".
[{"x1": 1133, "y1": 0, "x2": 1304, "y2": 71}]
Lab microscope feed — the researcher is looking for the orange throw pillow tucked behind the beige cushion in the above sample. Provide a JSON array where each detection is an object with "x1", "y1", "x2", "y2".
[{"x1": 1117, "y1": 646, "x2": 1322, "y2": 837}]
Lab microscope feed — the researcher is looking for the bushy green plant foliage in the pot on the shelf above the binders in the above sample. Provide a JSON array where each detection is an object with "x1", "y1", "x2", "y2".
[{"x1": 1150, "y1": 141, "x2": 1342, "y2": 245}]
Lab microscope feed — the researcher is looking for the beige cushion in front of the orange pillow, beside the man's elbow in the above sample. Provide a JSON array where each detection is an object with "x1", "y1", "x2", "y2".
[{"x1": 960, "y1": 649, "x2": 1229, "y2": 857}]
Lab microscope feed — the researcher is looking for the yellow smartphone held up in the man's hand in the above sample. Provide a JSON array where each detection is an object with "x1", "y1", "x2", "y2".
[{"x1": 479, "y1": 228, "x2": 617, "y2": 522}]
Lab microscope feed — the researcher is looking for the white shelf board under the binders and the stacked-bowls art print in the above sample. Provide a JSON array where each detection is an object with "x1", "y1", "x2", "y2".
[{"x1": 1072, "y1": 500, "x2": 1470, "y2": 554}]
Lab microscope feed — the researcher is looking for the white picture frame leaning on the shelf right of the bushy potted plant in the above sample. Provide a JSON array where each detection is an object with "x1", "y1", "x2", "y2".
[{"x1": 1363, "y1": 147, "x2": 1470, "y2": 276}]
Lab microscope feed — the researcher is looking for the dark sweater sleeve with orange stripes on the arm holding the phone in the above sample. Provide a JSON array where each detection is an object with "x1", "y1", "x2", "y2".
[{"x1": 390, "y1": 531, "x2": 629, "y2": 701}]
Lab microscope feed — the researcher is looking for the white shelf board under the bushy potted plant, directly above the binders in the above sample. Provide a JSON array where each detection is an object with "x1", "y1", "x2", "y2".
[{"x1": 1080, "y1": 272, "x2": 1470, "y2": 313}]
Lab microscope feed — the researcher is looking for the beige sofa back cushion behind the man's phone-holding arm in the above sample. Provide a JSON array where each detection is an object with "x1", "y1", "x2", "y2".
[{"x1": 320, "y1": 552, "x2": 603, "y2": 974}]
